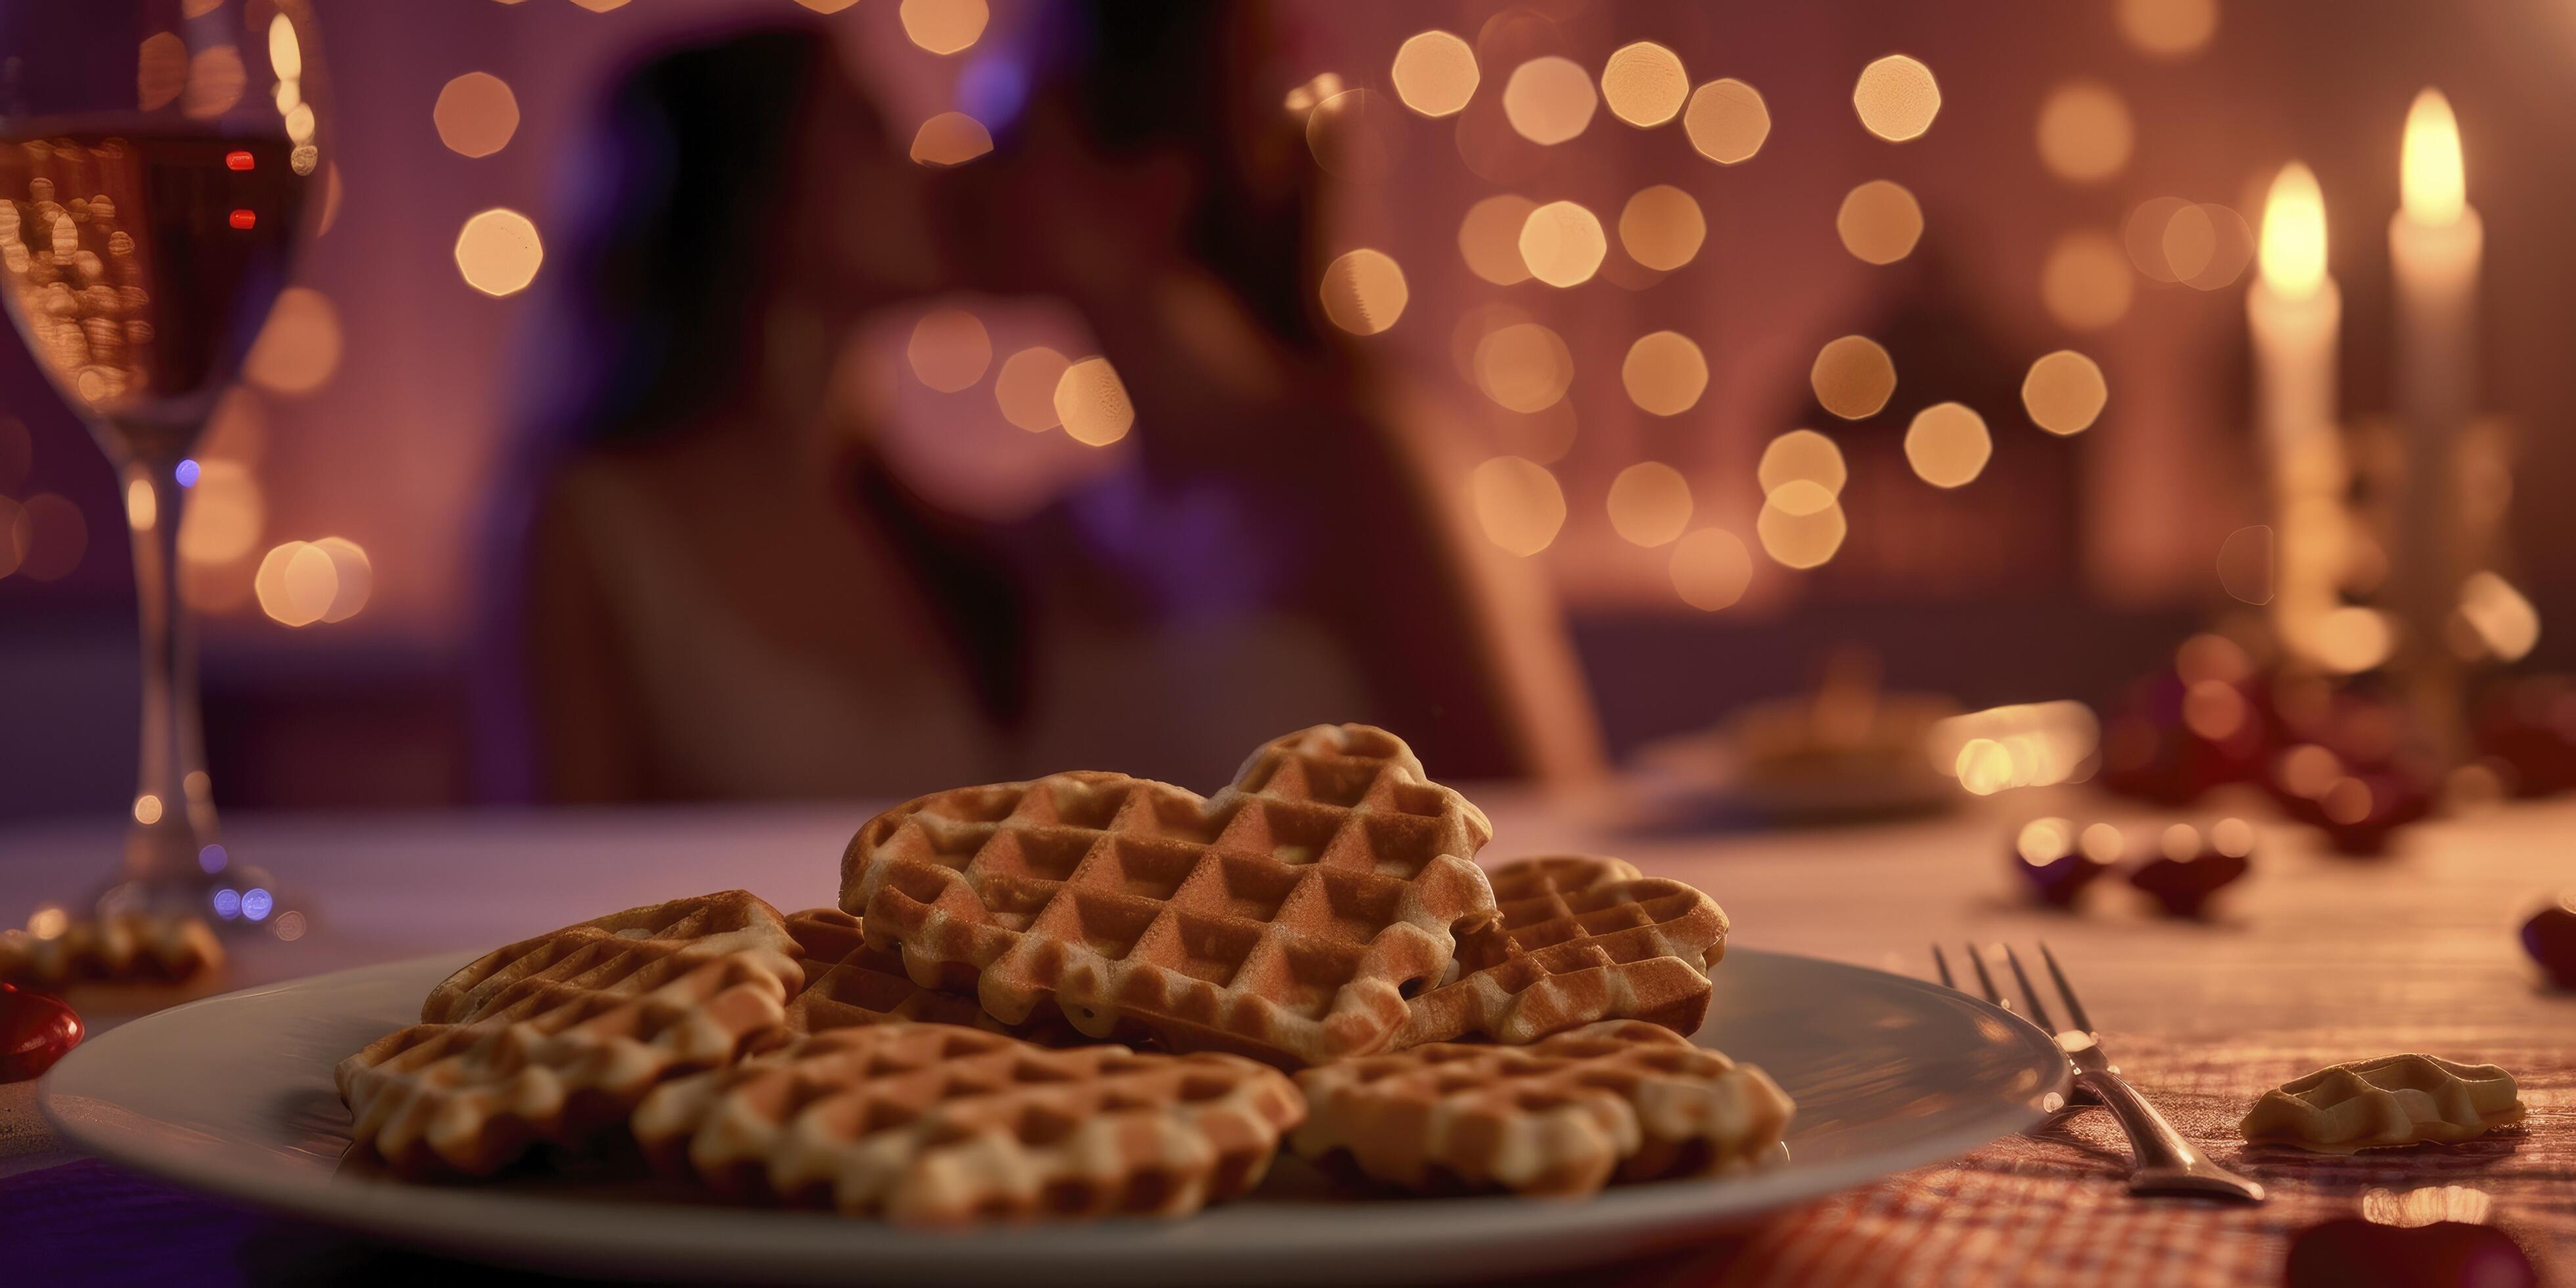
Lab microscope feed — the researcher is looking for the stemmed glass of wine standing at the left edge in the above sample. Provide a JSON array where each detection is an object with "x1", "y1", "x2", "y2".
[{"x1": 0, "y1": 0, "x2": 327, "y2": 925}]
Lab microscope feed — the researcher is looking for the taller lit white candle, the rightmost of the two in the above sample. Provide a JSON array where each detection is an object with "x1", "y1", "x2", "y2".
[{"x1": 2388, "y1": 90, "x2": 2486, "y2": 757}]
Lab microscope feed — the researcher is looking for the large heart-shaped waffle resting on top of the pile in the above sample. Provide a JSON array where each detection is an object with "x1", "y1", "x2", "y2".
[{"x1": 840, "y1": 724, "x2": 1494, "y2": 1067}]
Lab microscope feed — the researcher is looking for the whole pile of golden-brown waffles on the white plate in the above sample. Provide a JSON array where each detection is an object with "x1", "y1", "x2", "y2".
[{"x1": 340, "y1": 724, "x2": 1790, "y2": 1226}]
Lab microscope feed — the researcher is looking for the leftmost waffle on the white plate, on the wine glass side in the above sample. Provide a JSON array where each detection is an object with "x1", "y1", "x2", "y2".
[{"x1": 338, "y1": 891, "x2": 804, "y2": 1175}]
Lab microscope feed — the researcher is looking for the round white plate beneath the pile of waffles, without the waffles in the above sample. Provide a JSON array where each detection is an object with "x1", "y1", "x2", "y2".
[{"x1": 39, "y1": 948, "x2": 2066, "y2": 1283}]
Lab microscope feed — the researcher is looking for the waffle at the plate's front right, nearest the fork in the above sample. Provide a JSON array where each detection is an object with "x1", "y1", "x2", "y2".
[{"x1": 1293, "y1": 1020, "x2": 1795, "y2": 1195}]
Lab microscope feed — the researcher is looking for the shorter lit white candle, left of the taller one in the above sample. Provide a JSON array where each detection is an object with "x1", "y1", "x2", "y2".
[{"x1": 2246, "y1": 162, "x2": 2344, "y2": 662}]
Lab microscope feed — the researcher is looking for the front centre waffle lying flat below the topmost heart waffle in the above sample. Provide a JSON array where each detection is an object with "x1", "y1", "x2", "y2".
[{"x1": 633, "y1": 1023, "x2": 1306, "y2": 1226}]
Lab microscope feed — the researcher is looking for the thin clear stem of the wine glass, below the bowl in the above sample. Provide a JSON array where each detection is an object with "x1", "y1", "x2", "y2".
[{"x1": 121, "y1": 459, "x2": 216, "y2": 886}]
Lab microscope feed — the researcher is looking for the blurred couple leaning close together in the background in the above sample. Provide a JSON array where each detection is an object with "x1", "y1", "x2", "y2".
[{"x1": 482, "y1": 0, "x2": 1599, "y2": 801}]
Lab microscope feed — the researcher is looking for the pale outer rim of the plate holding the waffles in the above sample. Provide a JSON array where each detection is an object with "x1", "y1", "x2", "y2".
[{"x1": 36, "y1": 948, "x2": 2071, "y2": 1283}]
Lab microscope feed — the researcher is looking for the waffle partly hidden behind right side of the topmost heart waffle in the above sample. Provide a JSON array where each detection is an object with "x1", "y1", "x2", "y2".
[{"x1": 1396, "y1": 855, "x2": 1726, "y2": 1048}]
